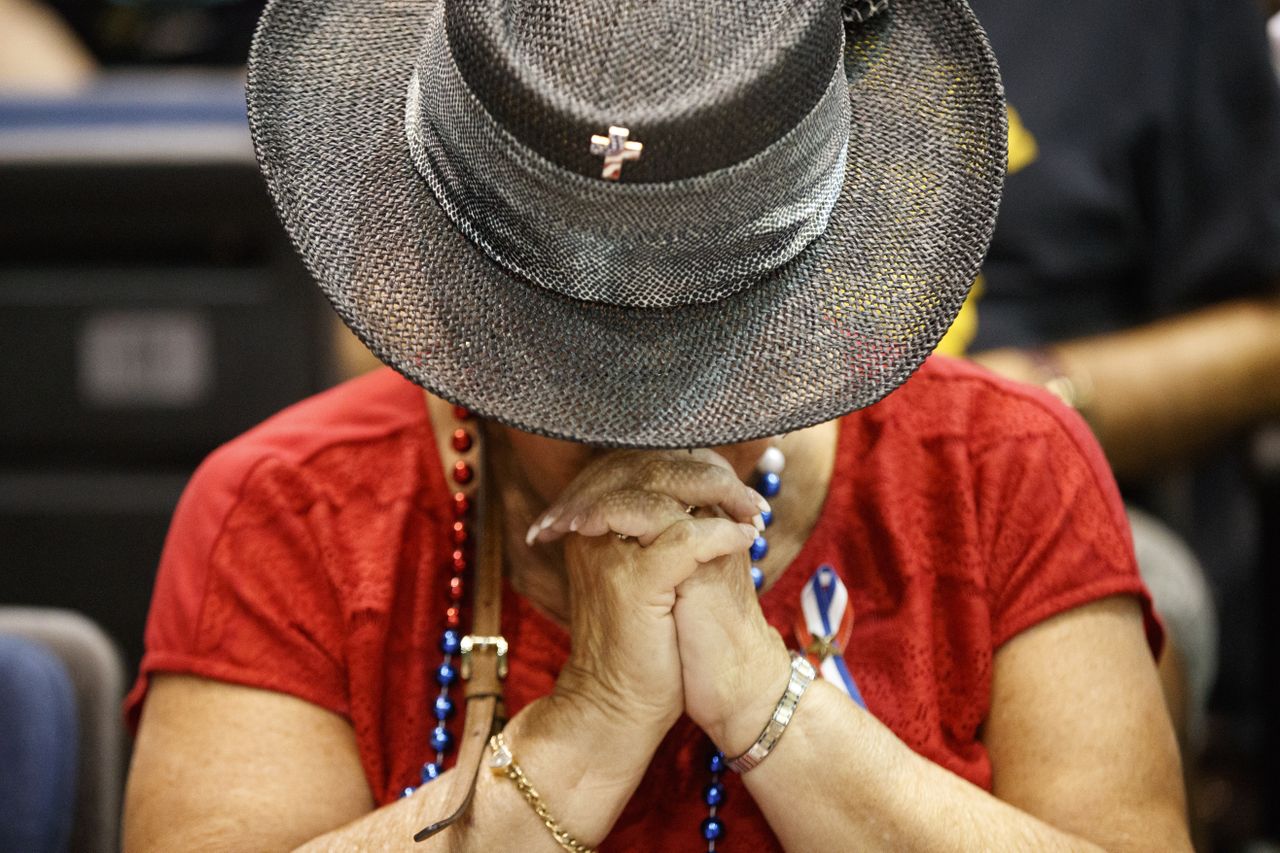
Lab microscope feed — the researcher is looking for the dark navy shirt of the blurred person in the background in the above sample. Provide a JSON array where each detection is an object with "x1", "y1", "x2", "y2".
[{"x1": 970, "y1": 0, "x2": 1280, "y2": 351}]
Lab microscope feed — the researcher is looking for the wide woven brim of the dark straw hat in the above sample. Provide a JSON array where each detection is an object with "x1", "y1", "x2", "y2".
[{"x1": 248, "y1": 0, "x2": 1006, "y2": 447}]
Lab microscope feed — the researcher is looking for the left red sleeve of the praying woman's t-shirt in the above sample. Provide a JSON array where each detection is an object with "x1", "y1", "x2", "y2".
[{"x1": 125, "y1": 443, "x2": 347, "y2": 727}]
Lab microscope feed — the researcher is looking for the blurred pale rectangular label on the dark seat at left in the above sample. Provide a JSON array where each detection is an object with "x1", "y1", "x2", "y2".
[{"x1": 79, "y1": 311, "x2": 214, "y2": 406}]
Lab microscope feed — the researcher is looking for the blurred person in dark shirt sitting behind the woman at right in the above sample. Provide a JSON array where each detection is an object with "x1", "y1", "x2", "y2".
[{"x1": 931, "y1": 0, "x2": 1280, "y2": 844}]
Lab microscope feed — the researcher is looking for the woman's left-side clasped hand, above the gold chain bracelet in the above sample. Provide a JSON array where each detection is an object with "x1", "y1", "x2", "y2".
[{"x1": 542, "y1": 452, "x2": 760, "y2": 731}]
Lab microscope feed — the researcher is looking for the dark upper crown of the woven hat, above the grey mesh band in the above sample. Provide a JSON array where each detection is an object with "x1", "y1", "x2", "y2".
[{"x1": 444, "y1": 0, "x2": 844, "y2": 183}]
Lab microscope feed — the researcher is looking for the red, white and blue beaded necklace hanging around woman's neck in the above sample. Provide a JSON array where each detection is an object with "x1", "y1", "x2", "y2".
[{"x1": 401, "y1": 406, "x2": 860, "y2": 853}]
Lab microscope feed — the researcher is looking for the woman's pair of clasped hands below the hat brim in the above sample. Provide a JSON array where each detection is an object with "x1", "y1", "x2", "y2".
[{"x1": 530, "y1": 451, "x2": 788, "y2": 754}]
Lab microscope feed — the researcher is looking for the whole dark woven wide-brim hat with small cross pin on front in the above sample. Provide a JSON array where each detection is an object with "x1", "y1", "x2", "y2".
[{"x1": 248, "y1": 0, "x2": 1006, "y2": 447}]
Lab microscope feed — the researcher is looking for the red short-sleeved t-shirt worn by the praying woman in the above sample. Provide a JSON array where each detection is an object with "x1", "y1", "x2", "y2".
[{"x1": 127, "y1": 357, "x2": 1160, "y2": 850}]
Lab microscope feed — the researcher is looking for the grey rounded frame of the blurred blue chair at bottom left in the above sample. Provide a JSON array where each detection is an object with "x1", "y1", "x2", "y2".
[{"x1": 0, "y1": 607, "x2": 125, "y2": 853}]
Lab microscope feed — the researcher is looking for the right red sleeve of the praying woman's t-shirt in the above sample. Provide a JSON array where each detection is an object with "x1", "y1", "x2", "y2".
[{"x1": 975, "y1": 389, "x2": 1162, "y2": 654}]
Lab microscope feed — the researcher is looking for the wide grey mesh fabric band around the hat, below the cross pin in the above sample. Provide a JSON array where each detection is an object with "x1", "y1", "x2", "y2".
[{"x1": 404, "y1": 4, "x2": 850, "y2": 307}]
